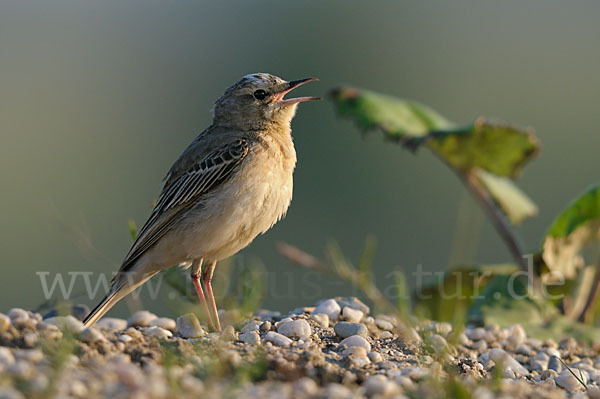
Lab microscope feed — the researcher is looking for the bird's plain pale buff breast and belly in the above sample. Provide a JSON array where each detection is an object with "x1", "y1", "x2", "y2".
[{"x1": 182, "y1": 153, "x2": 293, "y2": 260}]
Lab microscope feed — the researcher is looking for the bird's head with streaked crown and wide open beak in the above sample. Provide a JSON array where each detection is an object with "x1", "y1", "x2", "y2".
[{"x1": 213, "y1": 73, "x2": 320, "y2": 130}]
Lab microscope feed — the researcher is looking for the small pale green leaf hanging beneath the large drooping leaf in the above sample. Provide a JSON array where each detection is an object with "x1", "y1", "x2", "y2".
[{"x1": 474, "y1": 169, "x2": 538, "y2": 224}]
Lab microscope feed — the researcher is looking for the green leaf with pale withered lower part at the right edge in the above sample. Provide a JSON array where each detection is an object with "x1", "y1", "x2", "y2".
[{"x1": 543, "y1": 185, "x2": 600, "y2": 279}]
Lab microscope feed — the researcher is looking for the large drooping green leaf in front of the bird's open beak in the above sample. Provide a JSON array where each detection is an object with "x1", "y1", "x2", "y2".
[{"x1": 331, "y1": 87, "x2": 539, "y2": 177}]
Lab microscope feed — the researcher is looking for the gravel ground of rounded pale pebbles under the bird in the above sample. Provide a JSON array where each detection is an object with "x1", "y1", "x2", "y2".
[{"x1": 0, "y1": 298, "x2": 600, "y2": 399}]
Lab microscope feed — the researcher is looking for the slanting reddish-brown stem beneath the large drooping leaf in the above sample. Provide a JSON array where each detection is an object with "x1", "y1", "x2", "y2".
[{"x1": 458, "y1": 172, "x2": 533, "y2": 277}]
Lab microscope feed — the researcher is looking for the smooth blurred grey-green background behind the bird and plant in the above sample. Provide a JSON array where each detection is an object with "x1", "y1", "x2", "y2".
[{"x1": 0, "y1": 0, "x2": 600, "y2": 315}]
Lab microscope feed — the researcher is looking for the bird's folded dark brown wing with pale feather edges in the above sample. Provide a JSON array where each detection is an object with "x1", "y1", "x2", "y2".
[{"x1": 119, "y1": 139, "x2": 249, "y2": 272}]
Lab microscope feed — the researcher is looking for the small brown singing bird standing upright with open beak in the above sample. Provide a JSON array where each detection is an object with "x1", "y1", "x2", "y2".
[{"x1": 83, "y1": 73, "x2": 321, "y2": 331}]
